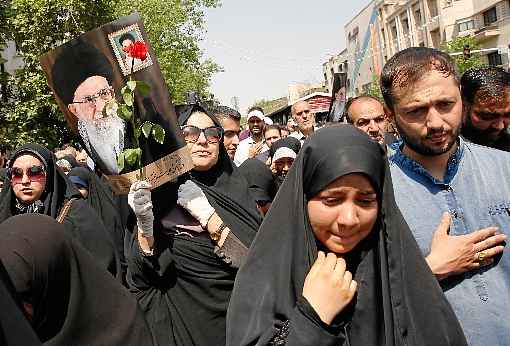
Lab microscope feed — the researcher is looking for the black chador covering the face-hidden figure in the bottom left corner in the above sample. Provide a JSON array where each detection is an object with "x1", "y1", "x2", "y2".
[{"x1": 0, "y1": 214, "x2": 153, "y2": 346}]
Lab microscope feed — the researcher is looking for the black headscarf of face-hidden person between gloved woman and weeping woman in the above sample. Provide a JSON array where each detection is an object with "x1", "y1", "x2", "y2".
[{"x1": 239, "y1": 159, "x2": 276, "y2": 202}]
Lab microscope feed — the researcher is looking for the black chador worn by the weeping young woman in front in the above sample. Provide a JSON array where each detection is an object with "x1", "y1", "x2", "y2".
[{"x1": 227, "y1": 125, "x2": 466, "y2": 346}]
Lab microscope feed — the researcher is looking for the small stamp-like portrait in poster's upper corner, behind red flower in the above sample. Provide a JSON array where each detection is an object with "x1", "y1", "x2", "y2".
[{"x1": 108, "y1": 24, "x2": 152, "y2": 76}]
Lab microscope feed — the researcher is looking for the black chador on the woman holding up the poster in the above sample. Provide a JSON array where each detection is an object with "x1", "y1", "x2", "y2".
[{"x1": 127, "y1": 107, "x2": 261, "y2": 346}]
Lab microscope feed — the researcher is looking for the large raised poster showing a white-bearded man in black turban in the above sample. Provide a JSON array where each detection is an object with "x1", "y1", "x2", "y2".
[{"x1": 40, "y1": 13, "x2": 193, "y2": 194}]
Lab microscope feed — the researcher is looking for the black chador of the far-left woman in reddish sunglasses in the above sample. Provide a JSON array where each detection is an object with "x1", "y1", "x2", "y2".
[{"x1": 0, "y1": 144, "x2": 120, "y2": 275}]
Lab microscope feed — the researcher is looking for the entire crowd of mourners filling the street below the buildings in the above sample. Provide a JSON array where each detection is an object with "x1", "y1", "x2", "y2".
[{"x1": 0, "y1": 47, "x2": 510, "y2": 346}]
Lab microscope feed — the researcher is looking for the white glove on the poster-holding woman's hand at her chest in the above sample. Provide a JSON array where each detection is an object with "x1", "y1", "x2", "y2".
[{"x1": 177, "y1": 180, "x2": 215, "y2": 228}]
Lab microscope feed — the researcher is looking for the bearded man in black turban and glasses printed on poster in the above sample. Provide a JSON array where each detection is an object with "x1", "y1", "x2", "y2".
[{"x1": 52, "y1": 42, "x2": 125, "y2": 174}]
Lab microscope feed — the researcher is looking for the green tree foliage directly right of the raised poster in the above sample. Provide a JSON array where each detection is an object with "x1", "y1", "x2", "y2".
[{"x1": 116, "y1": 0, "x2": 220, "y2": 103}]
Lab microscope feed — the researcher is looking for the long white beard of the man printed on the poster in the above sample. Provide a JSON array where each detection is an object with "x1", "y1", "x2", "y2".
[{"x1": 78, "y1": 115, "x2": 125, "y2": 174}]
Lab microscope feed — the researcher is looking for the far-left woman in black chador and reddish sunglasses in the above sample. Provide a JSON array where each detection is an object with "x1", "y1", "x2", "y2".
[{"x1": 0, "y1": 144, "x2": 120, "y2": 275}]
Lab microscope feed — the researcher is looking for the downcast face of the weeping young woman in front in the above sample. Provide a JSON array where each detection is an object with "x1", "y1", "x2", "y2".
[{"x1": 308, "y1": 174, "x2": 379, "y2": 254}]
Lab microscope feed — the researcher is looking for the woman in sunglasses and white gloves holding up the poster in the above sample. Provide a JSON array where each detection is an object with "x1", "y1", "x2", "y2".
[{"x1": 127, "y1": 106, "x2": 261, "y2": 346}]
